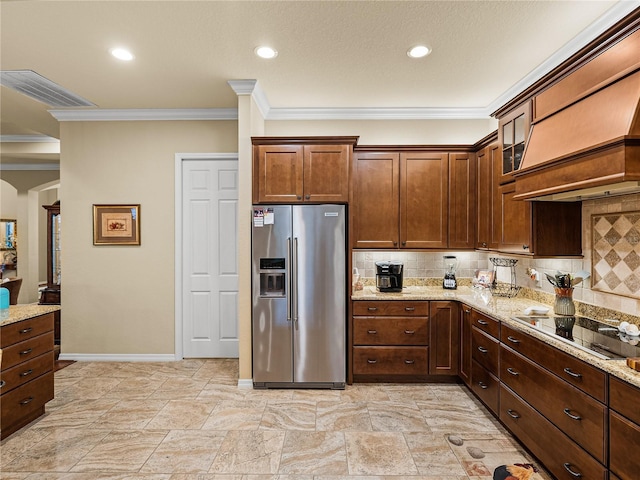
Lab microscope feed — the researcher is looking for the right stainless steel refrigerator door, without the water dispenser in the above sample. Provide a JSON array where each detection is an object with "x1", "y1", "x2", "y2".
[{"x1": 292, "y1": 205, "x2": 346, "y2": 383}]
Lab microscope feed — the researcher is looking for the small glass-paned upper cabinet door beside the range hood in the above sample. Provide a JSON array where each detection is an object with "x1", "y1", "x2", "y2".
[{"x1": 498, "y1": 101, "x2": 531, "y2": 183}]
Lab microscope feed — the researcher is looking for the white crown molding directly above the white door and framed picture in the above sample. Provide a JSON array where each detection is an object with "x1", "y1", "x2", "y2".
[{"x1": 49, "y1": 108, "x2": 238, "y2": 122}]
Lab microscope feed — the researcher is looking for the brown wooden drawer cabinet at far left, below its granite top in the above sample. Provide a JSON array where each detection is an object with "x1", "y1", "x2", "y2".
[{"x1": 0, "y1": 313, "x2": 54, "y2": 438}]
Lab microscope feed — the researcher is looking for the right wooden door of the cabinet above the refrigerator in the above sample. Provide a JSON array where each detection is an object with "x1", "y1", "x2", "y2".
[{"x1": 303, "y1": 145, "x2": 350, "y2": 203}]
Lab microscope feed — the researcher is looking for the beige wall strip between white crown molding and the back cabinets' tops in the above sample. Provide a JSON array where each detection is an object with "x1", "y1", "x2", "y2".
[{"x1": 265, "y1": 119, "x2": 498, "y2": 145}]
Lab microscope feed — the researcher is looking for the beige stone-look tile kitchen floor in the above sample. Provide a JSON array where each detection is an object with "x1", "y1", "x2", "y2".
[{"x1": 0, "y1": 359, "x2": 550, "y2": 480}]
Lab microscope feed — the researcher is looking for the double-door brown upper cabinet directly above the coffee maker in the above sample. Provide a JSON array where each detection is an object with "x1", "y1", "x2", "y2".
[{"x1": 351, "y1": 151, "x2": 449, "y2": 248}]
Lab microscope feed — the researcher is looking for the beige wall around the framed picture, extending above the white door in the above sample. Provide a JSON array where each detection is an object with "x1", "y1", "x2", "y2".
[{"x1": 60, "y1": 121, "x2": 238, "y2": 355}]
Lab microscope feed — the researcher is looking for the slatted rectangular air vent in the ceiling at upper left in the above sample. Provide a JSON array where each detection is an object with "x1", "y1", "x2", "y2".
[{"x1": 0, "y1": 70, "x2": 95, "y2": 107}]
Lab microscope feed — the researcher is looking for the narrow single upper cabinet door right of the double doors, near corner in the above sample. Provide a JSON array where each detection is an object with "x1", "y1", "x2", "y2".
[{"x1": 448, "y1": 153, "x2": 476, "y2": 248}]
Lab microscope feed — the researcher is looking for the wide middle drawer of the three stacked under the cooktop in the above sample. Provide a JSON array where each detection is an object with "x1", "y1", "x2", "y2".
[{"x1": 500, "y1": 346, "x2": 607, "y2": 464}]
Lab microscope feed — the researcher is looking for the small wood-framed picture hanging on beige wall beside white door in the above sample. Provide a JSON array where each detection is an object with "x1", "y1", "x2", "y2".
[{"x1": 93, "y1": 204, "x2": 140, "y2": 245}]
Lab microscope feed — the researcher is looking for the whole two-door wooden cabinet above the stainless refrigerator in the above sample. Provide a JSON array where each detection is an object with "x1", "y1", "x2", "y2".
[{"x1": 252, "y1": 137, "x2": 357, "y2": 203}]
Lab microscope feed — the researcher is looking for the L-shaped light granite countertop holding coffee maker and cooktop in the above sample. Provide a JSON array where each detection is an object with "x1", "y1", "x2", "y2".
[{"x1": 351, "y1": 286, "x2": 640, "y2": 387}]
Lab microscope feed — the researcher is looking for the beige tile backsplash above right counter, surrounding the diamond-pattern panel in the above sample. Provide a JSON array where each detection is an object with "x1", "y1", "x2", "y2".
[{"x1": 353, "y1": 194, "x2": 640, "y2": 318}]
